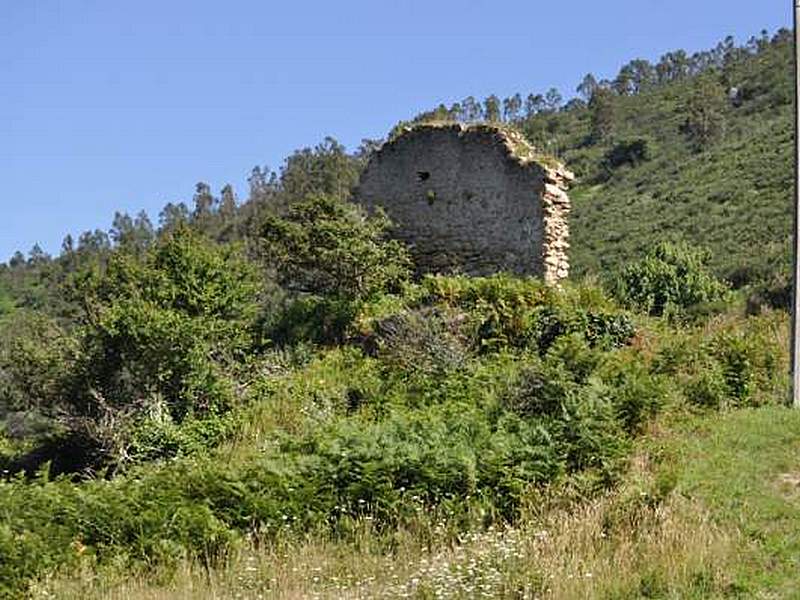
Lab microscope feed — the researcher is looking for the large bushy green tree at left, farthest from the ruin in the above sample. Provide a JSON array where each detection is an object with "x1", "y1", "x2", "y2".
[{"x1": 76, "y1": 227, "x2": 259, "y2": 421}]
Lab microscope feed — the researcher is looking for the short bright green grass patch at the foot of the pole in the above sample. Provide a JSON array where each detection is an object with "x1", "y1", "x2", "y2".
[{"x1": 669, "y1": 407, "x2": 800, "y2": 598}]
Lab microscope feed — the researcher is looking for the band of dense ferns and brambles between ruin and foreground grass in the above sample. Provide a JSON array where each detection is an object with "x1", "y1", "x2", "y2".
[{"x1": 0, "y1": 264, "x2": 785, "y2": 597}]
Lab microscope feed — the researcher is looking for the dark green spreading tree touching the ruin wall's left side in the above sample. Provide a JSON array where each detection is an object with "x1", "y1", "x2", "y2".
[{"x1": 261, "y1": 196, "x2": 411, "y2": 300}]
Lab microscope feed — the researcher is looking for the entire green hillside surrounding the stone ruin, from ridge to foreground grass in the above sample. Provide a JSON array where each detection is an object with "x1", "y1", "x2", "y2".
[{"x1": 0, "y1": 25, "x2": 800, "y2": 599}]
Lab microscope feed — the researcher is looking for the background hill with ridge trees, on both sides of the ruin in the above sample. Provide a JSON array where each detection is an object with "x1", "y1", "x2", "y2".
[{"x1": 0, "y1": 30, "x2": 792, "y2": 315}]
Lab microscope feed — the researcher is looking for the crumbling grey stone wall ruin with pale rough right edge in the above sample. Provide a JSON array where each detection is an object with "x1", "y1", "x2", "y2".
[{"x1": 355, "y1": 123, "x2": 574, "y2": 283}]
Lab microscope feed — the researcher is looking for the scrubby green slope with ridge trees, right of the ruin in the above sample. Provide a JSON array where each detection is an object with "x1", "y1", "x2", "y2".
[{"x1": 406, "y1": 30, "x2": 793, "y2": 292}]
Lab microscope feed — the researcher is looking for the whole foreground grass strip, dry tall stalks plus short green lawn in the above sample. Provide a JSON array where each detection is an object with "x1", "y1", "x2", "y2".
[{"x1": 34, "y1": 407, "x2": 800, "y2": 600}]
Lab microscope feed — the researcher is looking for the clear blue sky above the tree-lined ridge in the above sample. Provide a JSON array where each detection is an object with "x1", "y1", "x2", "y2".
[{"x1": 0, "y1": 0, "x2": 792, "y2": 261}]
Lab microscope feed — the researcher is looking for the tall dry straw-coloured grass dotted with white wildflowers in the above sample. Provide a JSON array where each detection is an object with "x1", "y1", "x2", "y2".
[{"x1": 33, "y1": 438, "x2": 739, "y2": 600}]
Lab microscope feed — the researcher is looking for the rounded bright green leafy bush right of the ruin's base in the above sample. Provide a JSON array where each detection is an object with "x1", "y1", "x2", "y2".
[{"x1": 610, "y1": 242, "x2": 727, "y2": 316}]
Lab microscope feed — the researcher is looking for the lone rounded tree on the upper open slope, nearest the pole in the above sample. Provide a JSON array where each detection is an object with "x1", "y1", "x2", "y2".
[{"x1": 681, "y1": 75, "x2": 727, "y2": 151}]
